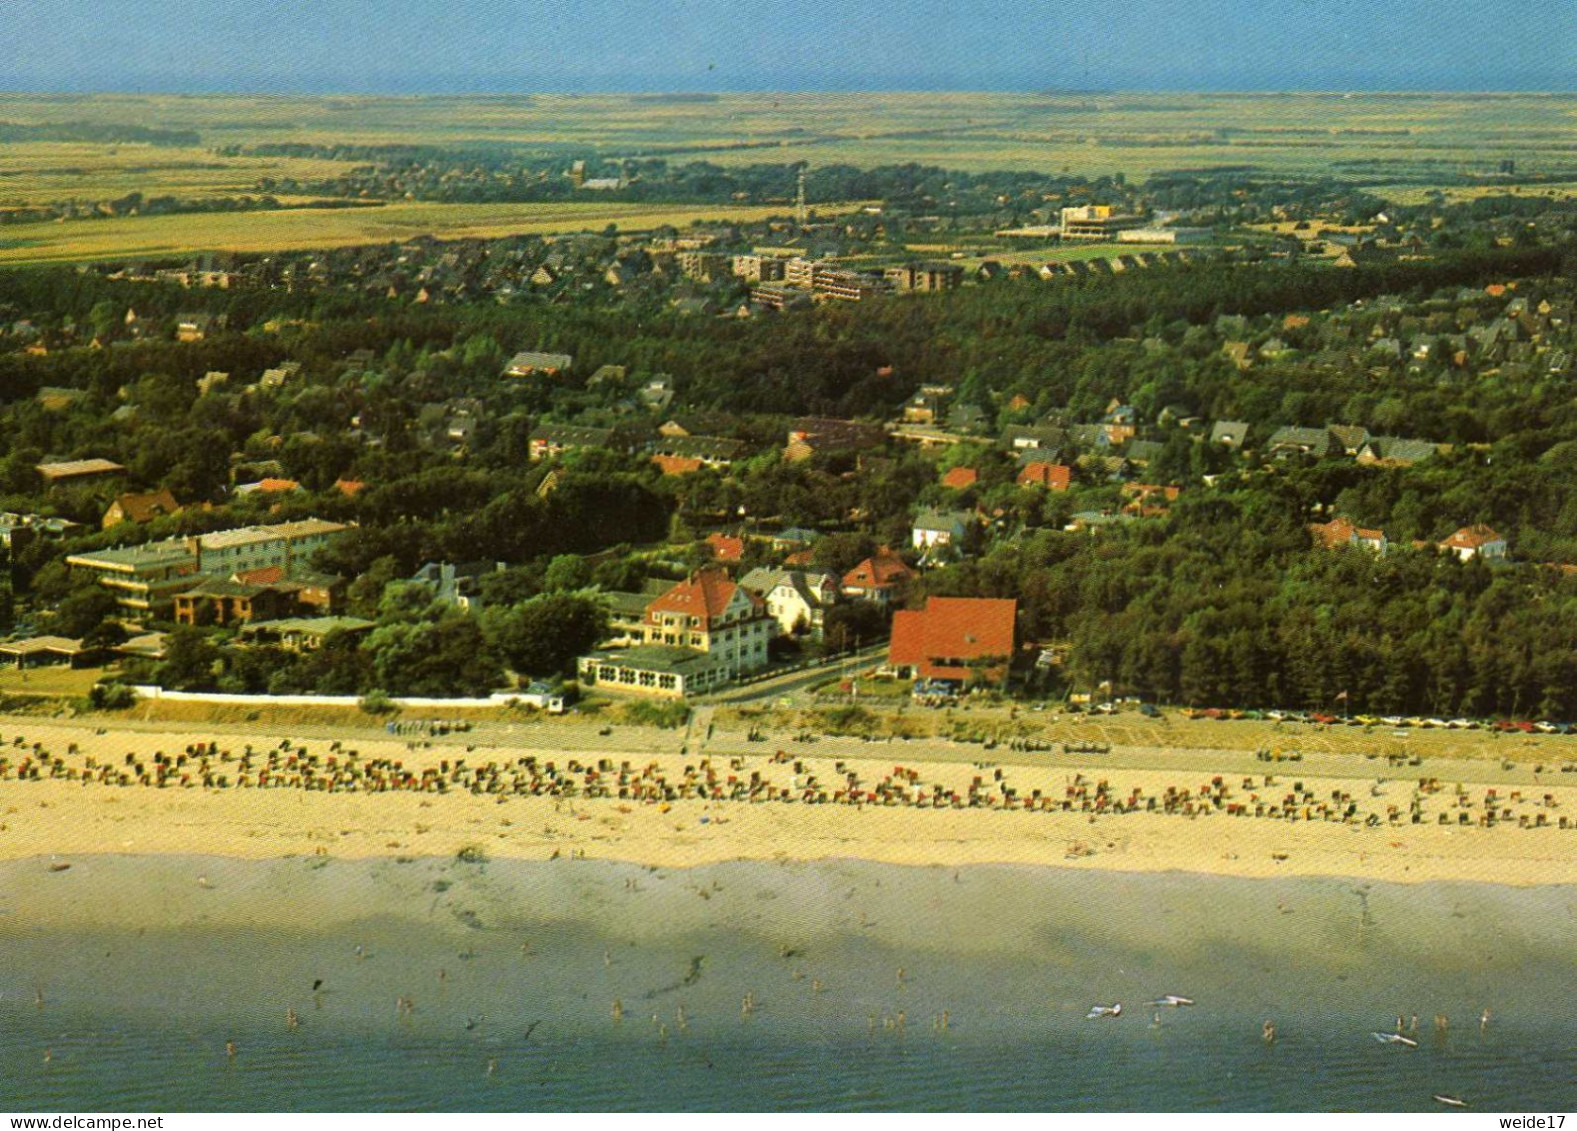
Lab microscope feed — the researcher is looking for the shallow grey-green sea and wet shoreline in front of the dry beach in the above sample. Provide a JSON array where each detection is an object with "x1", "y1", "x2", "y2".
[{"x1": 0, "y1": 860, "x2": 1577, "y2": 1112}]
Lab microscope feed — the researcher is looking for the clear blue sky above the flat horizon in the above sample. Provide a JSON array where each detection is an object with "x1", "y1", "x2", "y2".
[{"x1": 0, "y1": 0, "x2": 1577, "y2": 93}]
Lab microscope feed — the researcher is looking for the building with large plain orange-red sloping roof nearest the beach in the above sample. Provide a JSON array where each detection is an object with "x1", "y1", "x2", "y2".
[{"x1": 888, "y1": 596, "x2": 1019, "y2": 686}]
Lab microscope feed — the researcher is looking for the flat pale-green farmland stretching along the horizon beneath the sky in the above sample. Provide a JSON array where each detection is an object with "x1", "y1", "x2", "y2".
[{"x1": 0, "y1": 93, "x2": 1577, "y2": 180}]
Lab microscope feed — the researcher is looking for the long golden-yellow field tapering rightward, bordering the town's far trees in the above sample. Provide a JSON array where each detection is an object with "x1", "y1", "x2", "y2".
[{"x1": 0, "y1": 202, "x2": 859, "y2": 265}]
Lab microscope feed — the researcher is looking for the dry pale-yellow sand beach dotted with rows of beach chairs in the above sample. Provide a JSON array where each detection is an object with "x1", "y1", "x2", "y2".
[{"x1": 0, "y1": 716, "x2": 1577, "y2": 885}]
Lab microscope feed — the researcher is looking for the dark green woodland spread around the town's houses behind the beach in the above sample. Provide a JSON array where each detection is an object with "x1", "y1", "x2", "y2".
[{"x1": 0, "y1": 228, "x2": 1577, "y2": 718}]
